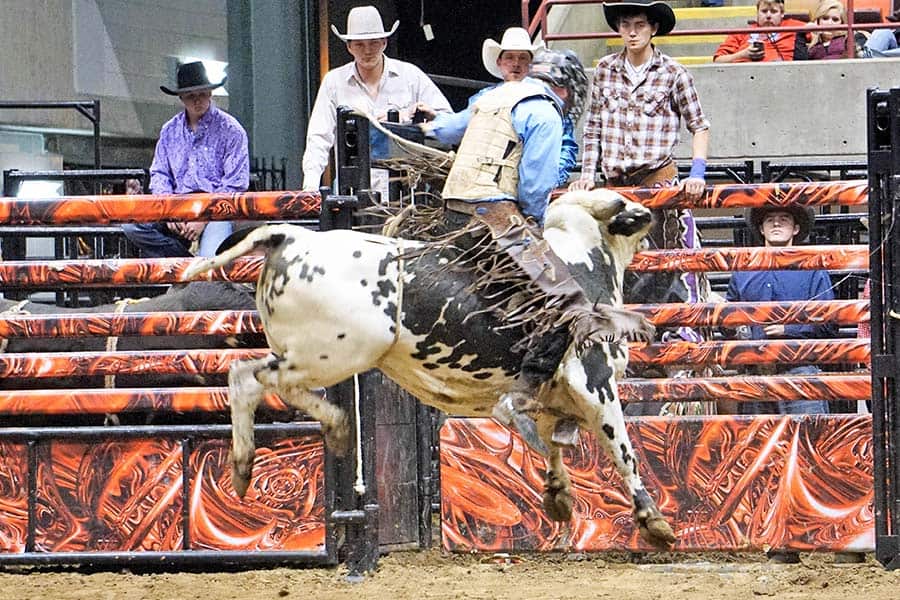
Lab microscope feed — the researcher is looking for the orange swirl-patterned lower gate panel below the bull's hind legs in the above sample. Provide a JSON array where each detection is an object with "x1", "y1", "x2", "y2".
[{"x1": 29, "y1": 435, "x2": 325, "y2": 552}]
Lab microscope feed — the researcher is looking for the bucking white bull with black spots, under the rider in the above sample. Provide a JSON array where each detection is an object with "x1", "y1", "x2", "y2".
[{"x1": 187, "y1": 190, "x2": 675, "y2": 547}]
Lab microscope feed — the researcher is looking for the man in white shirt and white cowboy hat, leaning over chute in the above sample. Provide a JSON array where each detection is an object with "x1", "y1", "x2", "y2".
[{"x1": 303, "y1": 6, "x2": 450, "y2": 191}]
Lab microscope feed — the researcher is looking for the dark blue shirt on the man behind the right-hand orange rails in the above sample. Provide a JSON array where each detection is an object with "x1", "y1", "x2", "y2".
[{"x1": 725, "y1": 271, "x2": 836, "y2": 340}]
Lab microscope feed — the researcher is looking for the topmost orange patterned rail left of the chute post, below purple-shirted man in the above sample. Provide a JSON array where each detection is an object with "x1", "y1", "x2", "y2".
[{"x1": 0, "y1": 192, "x2": 321, "y2": 225}]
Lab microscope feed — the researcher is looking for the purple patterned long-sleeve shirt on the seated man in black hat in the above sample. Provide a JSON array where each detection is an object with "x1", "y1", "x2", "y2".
[{"x1": 150, "y1": 104, "x2": 250, "y2": 194}]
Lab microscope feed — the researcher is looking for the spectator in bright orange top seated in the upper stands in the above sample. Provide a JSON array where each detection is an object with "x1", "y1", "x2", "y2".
[{"x1": 713, "y1": 0, "x2": 806, "y2": 63}]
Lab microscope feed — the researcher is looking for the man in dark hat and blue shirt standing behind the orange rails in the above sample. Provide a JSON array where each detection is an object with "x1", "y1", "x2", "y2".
[{"x1": 725, "y1": 205, "x2": 836, "y2": 414}]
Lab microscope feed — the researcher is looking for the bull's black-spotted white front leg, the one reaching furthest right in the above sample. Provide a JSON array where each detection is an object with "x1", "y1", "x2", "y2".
[{"x1": 561, "y1": 344, "x2": 676, "y2": 549}]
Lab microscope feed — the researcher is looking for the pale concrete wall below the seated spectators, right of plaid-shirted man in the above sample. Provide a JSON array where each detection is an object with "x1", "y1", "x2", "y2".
[{"x1": 678, "y1": 59, "x2": 900, "y2": 159}]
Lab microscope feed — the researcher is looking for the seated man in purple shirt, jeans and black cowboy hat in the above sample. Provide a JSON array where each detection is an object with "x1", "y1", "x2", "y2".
[{"x1": 122, "y1": 61, "x2": 250, "y2": 258}]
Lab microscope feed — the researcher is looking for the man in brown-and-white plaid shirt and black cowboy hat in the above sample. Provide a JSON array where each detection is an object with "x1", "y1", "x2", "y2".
[{"x1": 569, "y1": 0, "x2": 709, "y2": 410}]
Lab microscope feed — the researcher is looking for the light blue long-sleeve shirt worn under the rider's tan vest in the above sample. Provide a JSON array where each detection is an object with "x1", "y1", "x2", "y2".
[{"x1": 431, "y1": 79, "x2": 563, "y2": 224}]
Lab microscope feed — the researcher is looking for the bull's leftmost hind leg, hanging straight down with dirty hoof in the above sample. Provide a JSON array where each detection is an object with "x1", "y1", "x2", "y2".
[{"x1": 228, "y1": 355, "x2": 268, "y2": 498}]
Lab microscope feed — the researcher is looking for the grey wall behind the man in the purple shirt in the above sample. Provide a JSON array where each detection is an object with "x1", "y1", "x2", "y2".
[{"x1": 0, "y1": 0, "x2": 228, "y2": 145}]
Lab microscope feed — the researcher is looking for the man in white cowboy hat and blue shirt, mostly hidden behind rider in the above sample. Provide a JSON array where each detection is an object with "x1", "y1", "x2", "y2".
[{"x1": 478, "y1": 27, "x2": 587, "y2": 187}]
